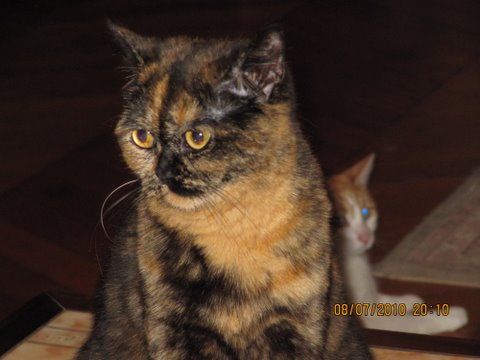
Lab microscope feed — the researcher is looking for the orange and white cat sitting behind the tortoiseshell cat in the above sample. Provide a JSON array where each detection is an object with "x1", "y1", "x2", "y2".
[{"x1": 329, "y1": 154, "x2": 468, "y2": 334}]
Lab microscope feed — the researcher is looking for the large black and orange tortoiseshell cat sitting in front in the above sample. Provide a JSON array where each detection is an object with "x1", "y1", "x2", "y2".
[{"x1": 79, "y1": 25, "x2": 370, "y2": 360}]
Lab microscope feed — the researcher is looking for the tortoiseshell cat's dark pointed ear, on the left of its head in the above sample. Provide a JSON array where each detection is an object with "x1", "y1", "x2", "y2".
[{"x1": 107, "y1": 20, "x2": 158, "y2": 71}]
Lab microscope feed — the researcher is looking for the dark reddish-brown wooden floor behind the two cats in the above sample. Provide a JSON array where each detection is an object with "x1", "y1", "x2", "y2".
[{"x1": 0, "y1": 0, "x2": 480, "y2": 339}]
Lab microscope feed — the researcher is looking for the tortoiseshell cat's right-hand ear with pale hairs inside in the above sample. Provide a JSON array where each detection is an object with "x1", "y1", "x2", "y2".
[{"x1": 228, "y1": 27, "x2": 285, "y2": 102}]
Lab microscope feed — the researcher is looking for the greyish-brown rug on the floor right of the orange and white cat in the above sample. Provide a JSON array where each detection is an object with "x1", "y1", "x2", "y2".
[{"x1": 374, "y1": 169, "x2": 480, "y2": 287}]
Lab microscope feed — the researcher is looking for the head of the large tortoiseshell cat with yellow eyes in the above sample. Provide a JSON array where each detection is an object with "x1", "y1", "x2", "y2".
[{"x1": 110, "y1": 25, "x2": 295, "y2": 210}]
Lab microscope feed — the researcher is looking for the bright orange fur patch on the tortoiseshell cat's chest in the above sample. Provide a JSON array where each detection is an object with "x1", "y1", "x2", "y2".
[{"x1": 141, "y1": 169, "x2": 325, "y2": 302}]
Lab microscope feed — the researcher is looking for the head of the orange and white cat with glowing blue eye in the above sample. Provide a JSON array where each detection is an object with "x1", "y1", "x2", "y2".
[{"x1": 329, "y1": 154, "x2": 378, "y2": 254}]
